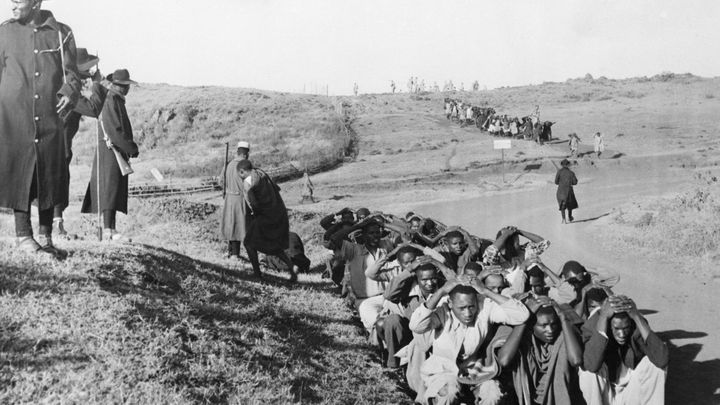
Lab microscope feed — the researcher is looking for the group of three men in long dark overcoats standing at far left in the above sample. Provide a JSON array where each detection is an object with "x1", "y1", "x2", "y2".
[{"x1": 0, "y1": 0, "x2": 138, "y2": 259}]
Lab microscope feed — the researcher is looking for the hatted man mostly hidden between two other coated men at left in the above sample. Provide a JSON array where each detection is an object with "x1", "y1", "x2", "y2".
[{"x1": 53, "y1": 48, "x2": 107, "y2": 239}]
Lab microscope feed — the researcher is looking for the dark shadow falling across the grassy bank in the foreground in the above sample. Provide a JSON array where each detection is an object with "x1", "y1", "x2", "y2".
[{"x1": 88, "y1": 241, "x2": 400, "y2": 403}]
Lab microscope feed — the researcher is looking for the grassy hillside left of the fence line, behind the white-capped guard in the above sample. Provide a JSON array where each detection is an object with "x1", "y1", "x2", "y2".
[{"x1": 74, "y1": 84, "x2": 352, "y2": 181}]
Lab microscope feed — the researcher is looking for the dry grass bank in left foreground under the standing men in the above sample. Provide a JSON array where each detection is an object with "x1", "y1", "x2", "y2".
[{"x1": 0, "y1": 199, "x2": 408, "y2": 404}]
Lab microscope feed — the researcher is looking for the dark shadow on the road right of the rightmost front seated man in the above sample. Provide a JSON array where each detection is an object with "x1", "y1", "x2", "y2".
[{"x1": 658, "y1": 329, "x2": 720, "y2": 405}]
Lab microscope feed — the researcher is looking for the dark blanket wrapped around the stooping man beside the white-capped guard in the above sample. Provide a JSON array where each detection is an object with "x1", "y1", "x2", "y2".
[{"x1": 245, "y1": 169, "x2": 290, "y2": 255}]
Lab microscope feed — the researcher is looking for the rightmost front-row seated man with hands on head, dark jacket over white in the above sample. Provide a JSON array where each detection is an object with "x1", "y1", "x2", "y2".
[{"x1": 580, "y1": 296, "x2": 669, "y2": 405}]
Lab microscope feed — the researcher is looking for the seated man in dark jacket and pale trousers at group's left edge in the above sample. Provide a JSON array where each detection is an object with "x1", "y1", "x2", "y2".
[{"x1": 330, "y1": 216, "x2": 400, "y2": 340}]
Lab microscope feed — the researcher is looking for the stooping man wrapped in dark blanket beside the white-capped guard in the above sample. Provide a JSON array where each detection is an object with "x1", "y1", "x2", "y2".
[{"x1": 237, "y1": 160, "x2": 297, "y2": 281}]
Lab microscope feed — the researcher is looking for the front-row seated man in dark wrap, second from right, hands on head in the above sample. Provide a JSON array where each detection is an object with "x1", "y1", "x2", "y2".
[{"x1": 498, "y1": 297, "x2": 585, "y2": 405}]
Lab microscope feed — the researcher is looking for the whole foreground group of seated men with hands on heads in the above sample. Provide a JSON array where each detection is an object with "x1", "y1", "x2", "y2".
[{"x1": 326, "y1": 211, "x2": 668, "y2": 404}]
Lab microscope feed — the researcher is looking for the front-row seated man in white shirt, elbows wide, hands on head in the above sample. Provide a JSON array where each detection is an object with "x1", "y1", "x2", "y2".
[{"x1": 410, "y1": 279, "x2": 529, "y2": 404}]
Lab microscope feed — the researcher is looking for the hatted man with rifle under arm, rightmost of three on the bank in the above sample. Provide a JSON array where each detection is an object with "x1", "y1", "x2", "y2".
[{"x1": 81, "y1": 69, "x2": 138, "y2": 242}]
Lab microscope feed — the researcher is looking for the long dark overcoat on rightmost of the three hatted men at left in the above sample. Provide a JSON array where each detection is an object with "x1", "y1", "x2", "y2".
[{"x1": 81, "y1": 90, "x2": 138, "y2": 214}]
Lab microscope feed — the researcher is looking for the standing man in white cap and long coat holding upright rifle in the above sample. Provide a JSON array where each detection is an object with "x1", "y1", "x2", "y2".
[{"x1": 220, "y1": 141, "x2": 250, "y2": 259}]
